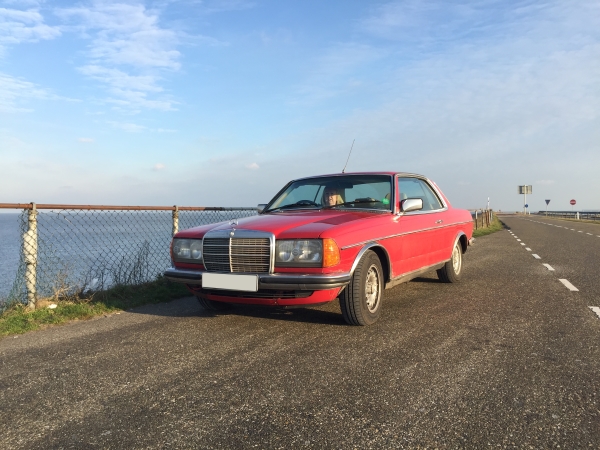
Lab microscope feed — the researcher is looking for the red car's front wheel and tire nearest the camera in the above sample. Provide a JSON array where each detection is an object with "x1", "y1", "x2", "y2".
[{"x1": 340, "y1": 250, "x2": 384, "y2": 326}]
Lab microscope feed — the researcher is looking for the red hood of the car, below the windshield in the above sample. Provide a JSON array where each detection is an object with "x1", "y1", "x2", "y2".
[{"x1": 177, "y1": 210, "x2": 385, "y2": 239}]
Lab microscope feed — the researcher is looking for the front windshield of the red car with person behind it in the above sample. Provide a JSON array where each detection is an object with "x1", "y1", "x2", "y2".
[{"x1": 266, "y1": 175, "x2": 392, "y2": 211}]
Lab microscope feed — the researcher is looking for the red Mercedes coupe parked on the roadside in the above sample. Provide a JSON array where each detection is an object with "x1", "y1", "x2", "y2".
[{"x1": 165, "y1": 172, "x2": 473, "y2": 325}]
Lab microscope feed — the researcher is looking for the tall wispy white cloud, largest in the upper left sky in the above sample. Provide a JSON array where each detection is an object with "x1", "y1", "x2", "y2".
[{"x1": 57, "y1": 1, "x2": 181, "y2": 111}]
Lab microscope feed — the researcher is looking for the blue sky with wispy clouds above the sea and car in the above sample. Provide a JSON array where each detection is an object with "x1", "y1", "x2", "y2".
[{"x1": 0, "y1": 0, "x2": 600, "y2": 210}]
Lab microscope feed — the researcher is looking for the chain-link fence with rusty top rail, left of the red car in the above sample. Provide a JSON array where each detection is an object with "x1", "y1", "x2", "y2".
[{"x1": 0, "y1": 203, "x2": 257, "y2": 311}]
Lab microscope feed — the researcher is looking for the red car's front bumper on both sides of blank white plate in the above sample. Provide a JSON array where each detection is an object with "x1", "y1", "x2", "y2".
[{"x1": 164, "y1": 267, "x2": 352, "y2": 291}]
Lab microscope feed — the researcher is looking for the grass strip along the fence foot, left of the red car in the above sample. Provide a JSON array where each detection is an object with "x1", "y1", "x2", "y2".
[{"x1": 0, "y1": 277, "x2": 191, "y2": 336}]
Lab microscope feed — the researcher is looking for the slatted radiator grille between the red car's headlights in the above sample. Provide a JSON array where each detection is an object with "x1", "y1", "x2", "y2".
[{"x1": 203, "y1": 237, "x2": 271, "y2": 273}]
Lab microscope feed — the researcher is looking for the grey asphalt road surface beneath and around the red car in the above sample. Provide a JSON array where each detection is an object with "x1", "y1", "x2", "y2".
[{"x1": 0, "y1": 217, "x2": 600, "y2": 449}]
